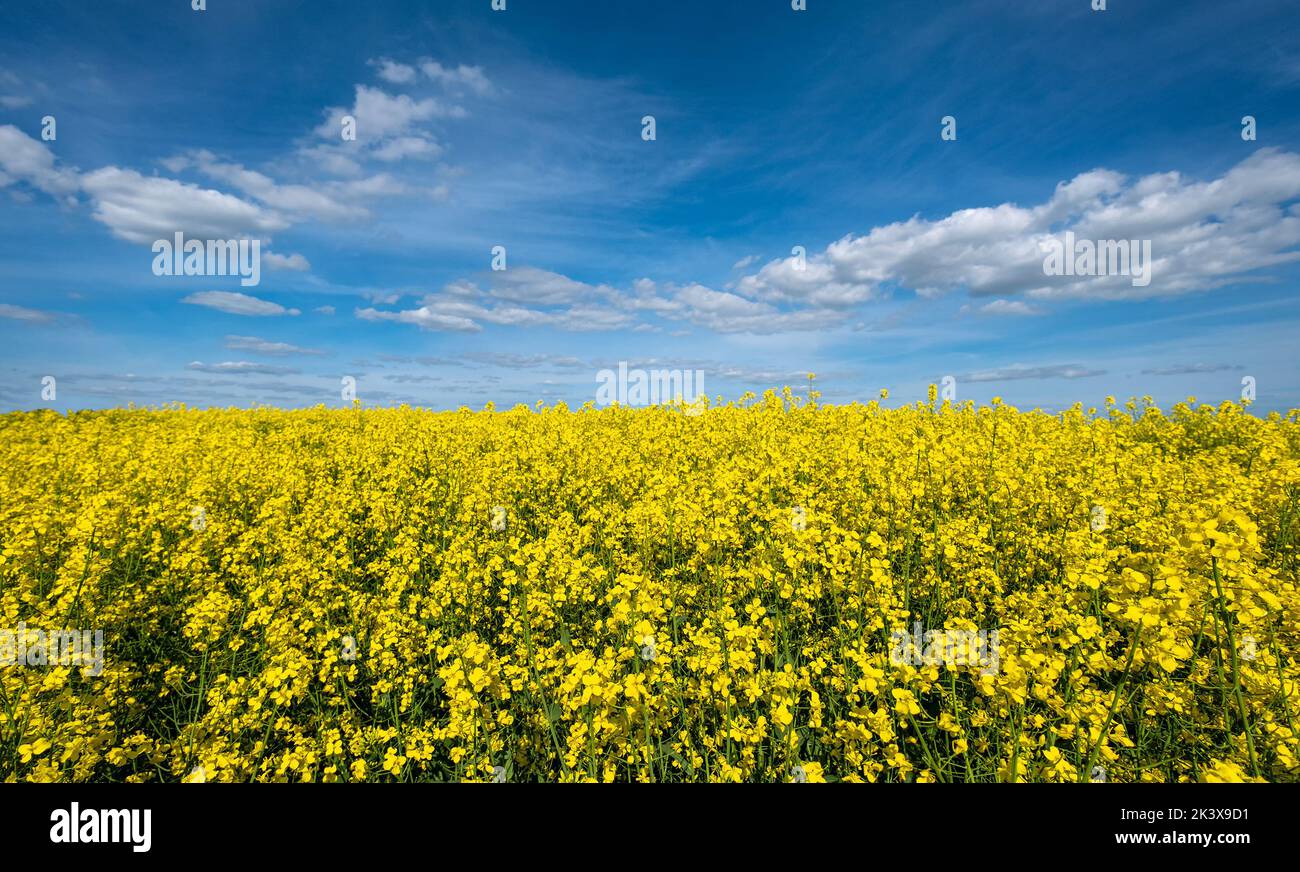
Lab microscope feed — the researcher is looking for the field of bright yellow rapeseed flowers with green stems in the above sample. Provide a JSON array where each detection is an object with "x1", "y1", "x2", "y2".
[{"x1": 0, "y1": 390, "x2": 1300, "y2": 782}]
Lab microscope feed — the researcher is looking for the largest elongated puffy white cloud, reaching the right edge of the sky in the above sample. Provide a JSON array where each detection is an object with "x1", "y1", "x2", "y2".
[{"x1": 736, "y1": 148, "x2": 1300, "y2": 307}]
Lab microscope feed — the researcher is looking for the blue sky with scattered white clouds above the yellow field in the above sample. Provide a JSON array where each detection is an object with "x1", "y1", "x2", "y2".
[{"x1": 0, "y1": 0, "x2": 1300, "y2": 411}]
